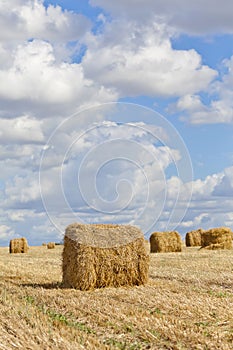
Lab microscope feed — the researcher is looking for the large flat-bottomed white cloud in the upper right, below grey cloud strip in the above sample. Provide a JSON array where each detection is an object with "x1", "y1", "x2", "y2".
[{"x1": 82, "y1": 20, "x2": 217, "y2": 96}]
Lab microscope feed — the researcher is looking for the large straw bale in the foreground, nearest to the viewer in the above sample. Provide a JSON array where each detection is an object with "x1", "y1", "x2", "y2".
[{"x1": 63, "y1": 223, "x2": 149, "y2": 290}]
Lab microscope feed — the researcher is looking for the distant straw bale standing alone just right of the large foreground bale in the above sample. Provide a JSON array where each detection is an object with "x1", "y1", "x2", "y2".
[{"x1": 150, "y1": 231, "x2": 182, "y2": 253}]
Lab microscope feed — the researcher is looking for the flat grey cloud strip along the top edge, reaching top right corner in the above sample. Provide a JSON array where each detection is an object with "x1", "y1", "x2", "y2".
[{"x1": 90, "y1": 0, "x2": 233, "y2": 35}]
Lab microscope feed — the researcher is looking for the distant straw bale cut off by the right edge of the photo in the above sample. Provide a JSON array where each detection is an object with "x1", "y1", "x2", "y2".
[{"x1": 201, "y1": 227, "x2": 232, "y2": 250}]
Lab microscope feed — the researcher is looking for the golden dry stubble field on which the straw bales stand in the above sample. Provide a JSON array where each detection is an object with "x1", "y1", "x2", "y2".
[{"x1": 0, "y1": 244, "x2": 233, "y2": 350}]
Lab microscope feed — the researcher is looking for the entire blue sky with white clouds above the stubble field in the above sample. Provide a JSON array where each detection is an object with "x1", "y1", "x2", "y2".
[{"x1": 0, "y1": 0, "x2": 233, "y2": 246}]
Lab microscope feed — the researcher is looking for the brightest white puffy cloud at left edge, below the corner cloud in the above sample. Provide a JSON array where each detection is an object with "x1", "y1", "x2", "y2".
[{"x1": 0, "y1": 40, "x2": 116, "y2": 110}]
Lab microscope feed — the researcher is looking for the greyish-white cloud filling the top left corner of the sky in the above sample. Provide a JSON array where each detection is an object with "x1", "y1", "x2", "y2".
[{"x1": 0, "y1": 0, "x2": 90, "y2": 42}]
